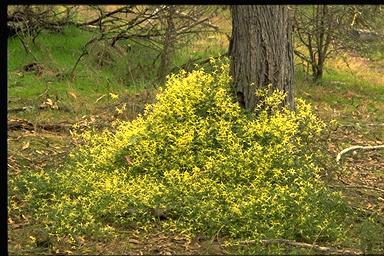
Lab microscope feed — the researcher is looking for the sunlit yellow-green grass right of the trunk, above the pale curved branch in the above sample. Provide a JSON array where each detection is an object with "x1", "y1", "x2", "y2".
[{"x1": 295, "y1": 57, "x2": 384, "y2": 140}]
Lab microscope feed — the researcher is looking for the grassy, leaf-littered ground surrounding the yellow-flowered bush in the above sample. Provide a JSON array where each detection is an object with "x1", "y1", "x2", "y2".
[{"x1": 7, "y1": 9, "x2": 384, "y2": 254}]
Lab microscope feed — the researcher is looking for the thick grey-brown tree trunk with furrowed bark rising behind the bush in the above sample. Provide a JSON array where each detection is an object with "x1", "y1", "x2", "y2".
[{"x1": 229, "y1": 5, "x2": 294, "y2": 110}]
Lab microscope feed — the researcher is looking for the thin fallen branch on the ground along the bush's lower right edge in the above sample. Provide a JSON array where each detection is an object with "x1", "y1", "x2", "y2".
[{"x1": 240, "y1": 239, "x2": 362, "y2": 255}]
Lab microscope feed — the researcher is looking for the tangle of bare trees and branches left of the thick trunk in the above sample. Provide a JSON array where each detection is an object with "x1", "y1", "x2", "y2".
[{"x1": 7, "y1": 5, "x2": 219, "y2": 84}]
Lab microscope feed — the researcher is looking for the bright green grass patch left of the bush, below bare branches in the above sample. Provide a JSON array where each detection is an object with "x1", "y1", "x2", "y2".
[{"x1": 8, "y1": 27, "x2": 159, "y2": 128}]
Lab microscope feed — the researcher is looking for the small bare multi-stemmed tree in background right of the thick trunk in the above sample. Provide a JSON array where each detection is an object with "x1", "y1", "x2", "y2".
[{"x1": 292, "y1": 5, "x2": 383, "y2": 81}]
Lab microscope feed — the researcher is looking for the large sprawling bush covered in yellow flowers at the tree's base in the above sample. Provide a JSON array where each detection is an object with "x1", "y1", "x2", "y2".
[{"x1": 10, "y1": 58, "x2": 346, "y2": 244}]
